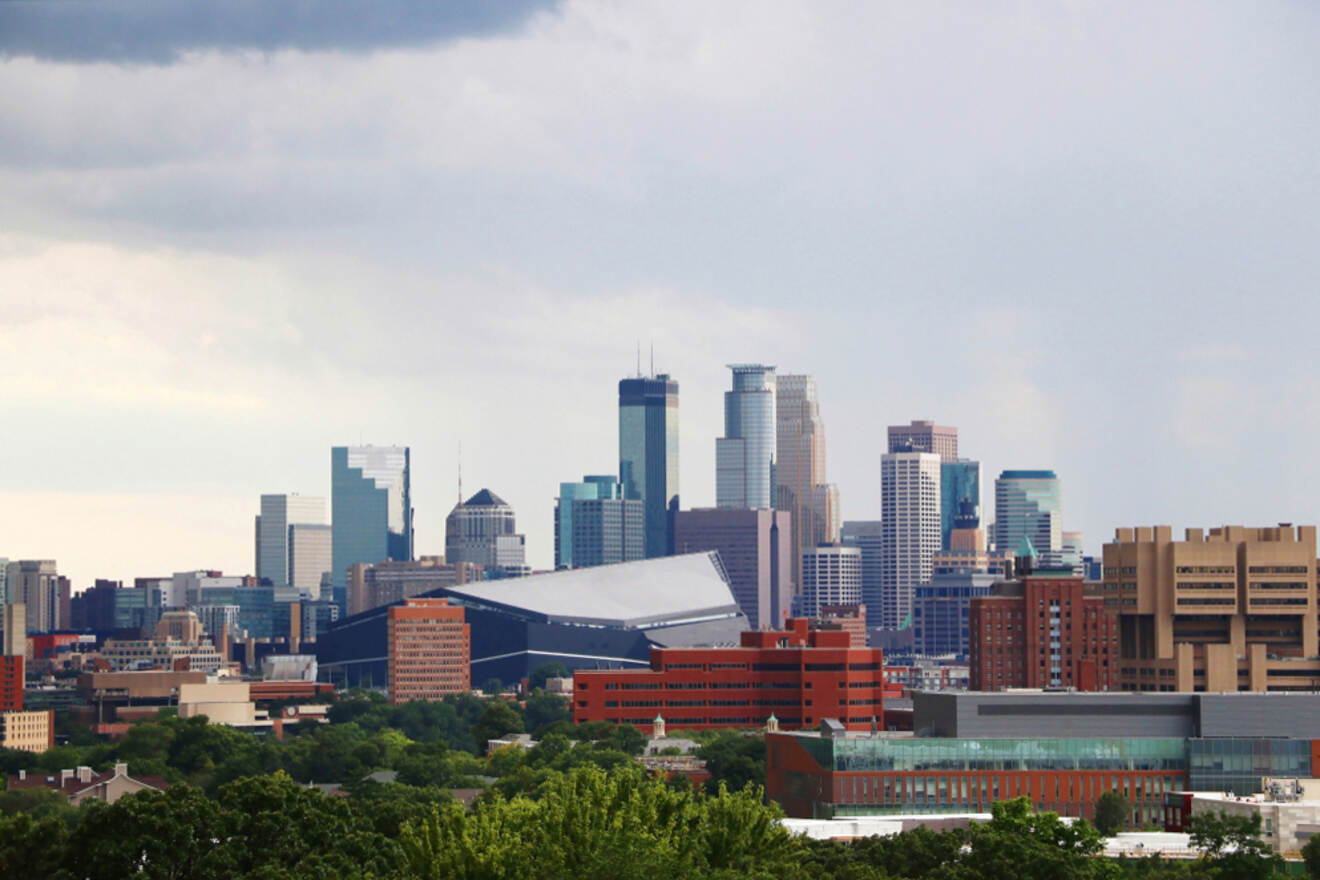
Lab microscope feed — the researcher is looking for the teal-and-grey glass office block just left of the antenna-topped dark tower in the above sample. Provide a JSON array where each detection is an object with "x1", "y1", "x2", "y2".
[{"x1": 554, "y1": 476, "x2": 645, "y2": 569}]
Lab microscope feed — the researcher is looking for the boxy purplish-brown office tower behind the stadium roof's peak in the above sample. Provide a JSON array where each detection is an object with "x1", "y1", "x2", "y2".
[{"x1": 673, "y1": 508, "x2": 795, "y2": 629}]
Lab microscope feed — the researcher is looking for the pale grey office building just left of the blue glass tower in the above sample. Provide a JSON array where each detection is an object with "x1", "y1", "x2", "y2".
[{"x1": 256, "y1": 495, "x2": 334, "y2": 598}]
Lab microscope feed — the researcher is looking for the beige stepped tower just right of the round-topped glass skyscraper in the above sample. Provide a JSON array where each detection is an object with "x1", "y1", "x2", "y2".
[{"x1": 775, "y1": 375, "x2": 838, "y2": 583}]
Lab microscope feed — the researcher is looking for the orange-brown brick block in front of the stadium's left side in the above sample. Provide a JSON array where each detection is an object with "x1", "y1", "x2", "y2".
[{"x1": 387, "y1": 599, "x2": 473, "y2": 706}]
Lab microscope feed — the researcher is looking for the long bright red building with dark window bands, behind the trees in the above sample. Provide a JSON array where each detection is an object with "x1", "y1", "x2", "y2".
[{"x1": 573, "y1": 619, "x2": 884, "y2": 731}]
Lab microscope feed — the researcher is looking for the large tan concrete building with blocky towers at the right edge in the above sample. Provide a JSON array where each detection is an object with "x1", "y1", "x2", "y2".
[{"x1": 1104, "y1": 524, "x2": 1320, "y2": 691}]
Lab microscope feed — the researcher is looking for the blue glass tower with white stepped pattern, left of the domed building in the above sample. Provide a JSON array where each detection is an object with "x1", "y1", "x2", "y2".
[{"x1": 330, "y1": 446, "x2": 413, "y2": 608}]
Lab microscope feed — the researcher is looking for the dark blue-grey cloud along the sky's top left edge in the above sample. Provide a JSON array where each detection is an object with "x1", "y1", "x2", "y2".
[{"x1": 0, "y1": 0, "x2": 556, "y2": 65}]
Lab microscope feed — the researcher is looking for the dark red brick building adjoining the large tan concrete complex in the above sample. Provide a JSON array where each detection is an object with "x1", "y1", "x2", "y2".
[{"x1": 969, "y1": 571, "x2": 1118, "y2": 690}]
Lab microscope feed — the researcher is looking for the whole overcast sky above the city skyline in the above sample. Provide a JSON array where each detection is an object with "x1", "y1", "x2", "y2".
[{"x1": 0, "y1": 0, "x2": 1320, "y2": 588}]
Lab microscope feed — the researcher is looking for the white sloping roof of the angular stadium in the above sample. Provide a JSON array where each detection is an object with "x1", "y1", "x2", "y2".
[{"x1": 444, "y1": 551, "x2": 739, "y2": 629}]
